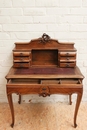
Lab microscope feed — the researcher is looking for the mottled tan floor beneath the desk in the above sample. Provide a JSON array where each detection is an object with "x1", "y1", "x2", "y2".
[{"x1": 0, "y1": 102, "x2": 87, "y2": 130}]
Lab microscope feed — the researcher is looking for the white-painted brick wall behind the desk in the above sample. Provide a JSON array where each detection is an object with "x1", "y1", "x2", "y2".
[{"x1": 0, "y1": 0, "x2": 87, "y2": 102}]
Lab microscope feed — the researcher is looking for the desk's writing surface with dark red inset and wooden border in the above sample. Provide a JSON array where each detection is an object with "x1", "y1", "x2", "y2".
[{"x1": 6, "y1": 67, "x2": 84, "y2": 79}]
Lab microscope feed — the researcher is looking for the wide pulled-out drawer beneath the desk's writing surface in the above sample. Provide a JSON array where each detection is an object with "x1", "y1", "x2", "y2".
[{"x1": 6, "y1": 79, "x2": 82, "y2": 97}]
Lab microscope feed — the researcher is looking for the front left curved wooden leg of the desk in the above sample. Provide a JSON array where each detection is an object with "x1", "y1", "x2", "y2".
[{"x1": 7, "y1": 94, "x2": 14, "y2": 127}]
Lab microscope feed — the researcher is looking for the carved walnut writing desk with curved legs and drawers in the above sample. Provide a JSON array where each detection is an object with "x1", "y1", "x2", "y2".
[{"x1": 6, "y1": 34, "x2": 84, "y2": 127}]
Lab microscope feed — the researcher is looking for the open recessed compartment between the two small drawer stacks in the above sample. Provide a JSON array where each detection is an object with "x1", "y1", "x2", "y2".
[{"x1": 32, "y1": 50, "x2": 58, "y2": 66}]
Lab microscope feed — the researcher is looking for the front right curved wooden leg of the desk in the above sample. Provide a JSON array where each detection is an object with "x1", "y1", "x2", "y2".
[{"x1": 74, "y1": 93, "x2": 82, "y2": 128}]
